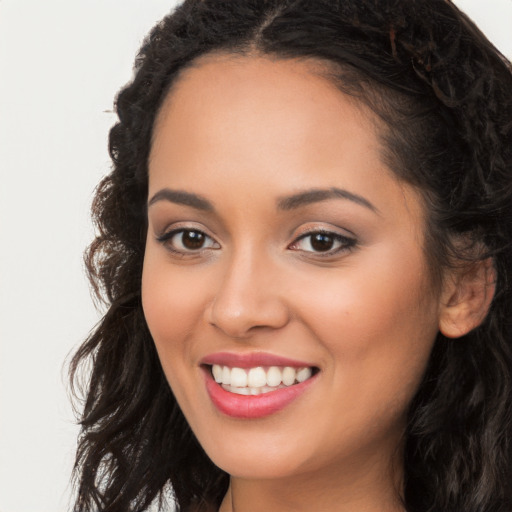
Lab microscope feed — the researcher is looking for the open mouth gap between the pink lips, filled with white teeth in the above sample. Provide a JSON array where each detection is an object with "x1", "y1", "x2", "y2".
[{"x1": 210, "y1": 364, "x2": 318, "y2": 396}]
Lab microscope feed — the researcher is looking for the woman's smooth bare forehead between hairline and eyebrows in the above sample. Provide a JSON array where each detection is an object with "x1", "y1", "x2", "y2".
[{"x1": 149, "y1": 55, "x2": 424, "y2": 226}]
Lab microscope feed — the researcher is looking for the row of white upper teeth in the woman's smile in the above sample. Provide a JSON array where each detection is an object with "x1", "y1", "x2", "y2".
[{"x1": 212, "y1": 364, "x2": 312, "y2": 388}]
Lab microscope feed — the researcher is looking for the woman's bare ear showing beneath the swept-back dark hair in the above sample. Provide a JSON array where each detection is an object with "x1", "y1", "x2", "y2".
[{"x1": 439, "y1": 258, "x2": 496, "y2": 338}]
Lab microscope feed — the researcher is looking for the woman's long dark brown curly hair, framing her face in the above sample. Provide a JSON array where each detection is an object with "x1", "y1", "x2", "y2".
[{"x1": 70, "y1": 0, "x2": 512, "y2": 512}]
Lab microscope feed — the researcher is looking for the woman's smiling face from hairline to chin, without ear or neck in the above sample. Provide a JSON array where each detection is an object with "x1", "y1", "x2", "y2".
[{"x1": 142, "y1": 56, "x2": 441, "y2": 484}]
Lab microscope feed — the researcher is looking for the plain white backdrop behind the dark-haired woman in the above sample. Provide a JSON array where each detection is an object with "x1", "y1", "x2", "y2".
[{"x1": 0, "y1": 0, "x2": 512, "y2": 512}]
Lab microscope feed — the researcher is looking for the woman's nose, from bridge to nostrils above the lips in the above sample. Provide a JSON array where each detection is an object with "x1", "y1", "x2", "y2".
[{"x1": 206, "y1": 249, "x2": 289, "y2": 338}]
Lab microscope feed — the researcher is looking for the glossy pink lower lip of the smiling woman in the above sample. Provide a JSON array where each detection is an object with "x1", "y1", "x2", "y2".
[{"x1": 205, "y1": 369, "x2": 317, "y2": 420}]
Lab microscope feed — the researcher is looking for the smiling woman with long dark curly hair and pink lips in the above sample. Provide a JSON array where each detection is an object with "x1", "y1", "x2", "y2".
[{"x1": 72, "y1": 0, "x2": 512, "y2": 512}]
